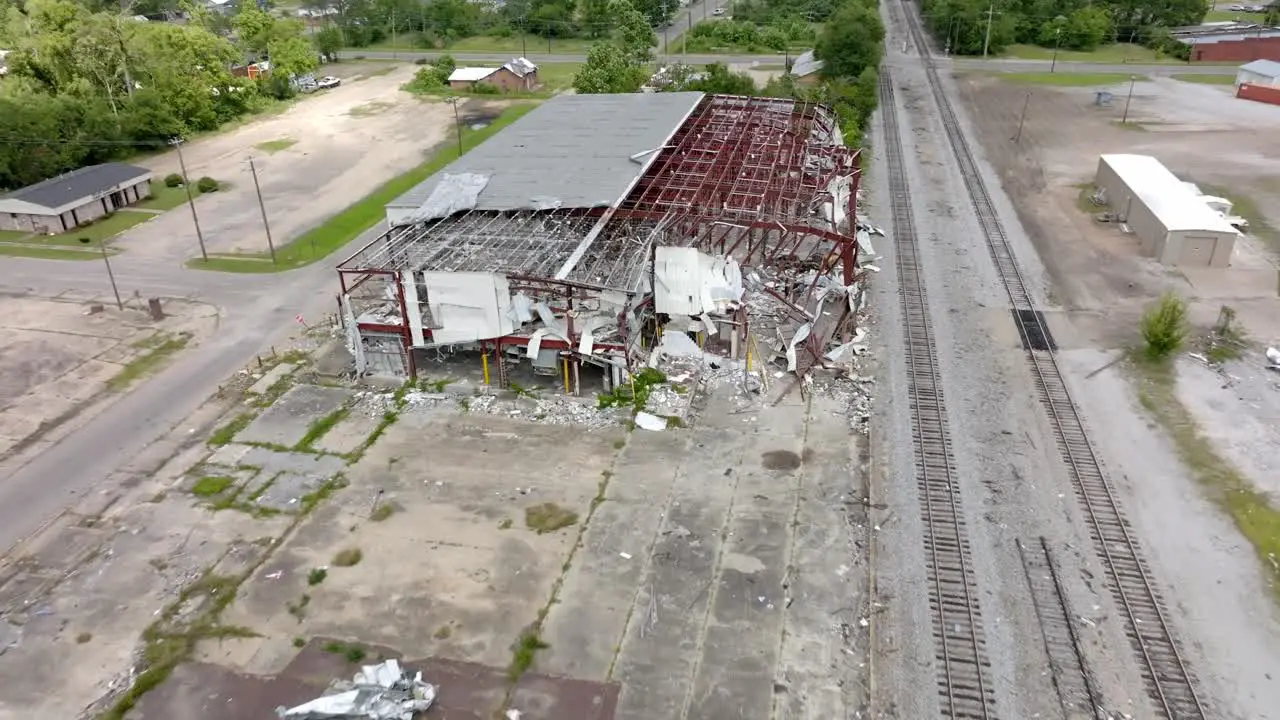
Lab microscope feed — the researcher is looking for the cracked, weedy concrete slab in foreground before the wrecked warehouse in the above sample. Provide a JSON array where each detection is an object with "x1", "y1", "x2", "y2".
[{"x1": 0, "y1": 338, "x2": 870, "y2": 720}]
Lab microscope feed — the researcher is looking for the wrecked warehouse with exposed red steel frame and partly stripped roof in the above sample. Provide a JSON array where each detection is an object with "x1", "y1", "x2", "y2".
[{"x1": 338, "y1": 92, "x2": 870, "y2": 393}]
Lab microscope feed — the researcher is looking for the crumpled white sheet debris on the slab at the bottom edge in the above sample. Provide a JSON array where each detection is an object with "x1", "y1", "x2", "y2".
[{"x1": 275, "y1": 660, "x2": 435, "y2": 720}]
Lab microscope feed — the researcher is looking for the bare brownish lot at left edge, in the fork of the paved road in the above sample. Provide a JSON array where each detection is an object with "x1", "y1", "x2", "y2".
[{"x1": 0, "y1": 293, "x2": 216, "y2": 470}]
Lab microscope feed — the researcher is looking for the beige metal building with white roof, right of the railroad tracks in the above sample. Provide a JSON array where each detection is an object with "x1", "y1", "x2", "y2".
[{"x1": 1094, "y1": 155, "x2": 1240, "y2": 268}]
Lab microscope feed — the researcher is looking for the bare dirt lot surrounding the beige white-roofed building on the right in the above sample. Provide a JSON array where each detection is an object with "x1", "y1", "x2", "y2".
[{"x1": 956, "y1": 74, "x2": 1280, "y2": 338}]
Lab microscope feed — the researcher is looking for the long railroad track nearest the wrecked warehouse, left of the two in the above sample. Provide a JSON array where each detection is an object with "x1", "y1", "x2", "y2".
[{"x1": 879, "y1": 68, "x2": 996, "y2": 720}]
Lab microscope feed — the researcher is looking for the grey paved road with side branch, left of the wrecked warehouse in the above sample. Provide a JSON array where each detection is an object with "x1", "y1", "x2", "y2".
[{"x1": 0, "y1": 221, "x2": 381, "y2": 550}]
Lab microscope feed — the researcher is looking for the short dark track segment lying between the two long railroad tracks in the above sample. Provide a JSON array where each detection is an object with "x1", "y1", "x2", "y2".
[{"x1": 1018, "y1": 537, "x2": 1101, "y2": 720}]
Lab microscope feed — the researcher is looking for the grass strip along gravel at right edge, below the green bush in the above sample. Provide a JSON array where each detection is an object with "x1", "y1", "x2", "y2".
[{"x1": 1133, "y1": 360, "x2": 1280, "y2": 602}]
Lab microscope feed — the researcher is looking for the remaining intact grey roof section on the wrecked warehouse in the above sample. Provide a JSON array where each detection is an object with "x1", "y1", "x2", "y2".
[{"x1": 387, "y1": 92, "x2": 703, "y2": 210}]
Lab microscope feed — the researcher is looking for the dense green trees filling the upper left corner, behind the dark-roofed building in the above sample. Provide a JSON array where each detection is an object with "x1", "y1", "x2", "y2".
[{"x1": 0, "y1": 0, "x2": 319, "y2": 190}]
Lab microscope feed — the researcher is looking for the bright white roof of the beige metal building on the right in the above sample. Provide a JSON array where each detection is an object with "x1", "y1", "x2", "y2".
[{"x1": 1102, "y1": 155, "x2": 1236, "y2": 234}]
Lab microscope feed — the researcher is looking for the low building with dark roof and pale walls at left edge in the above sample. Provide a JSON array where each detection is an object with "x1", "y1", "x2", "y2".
[{"x1": 0, "y1": 163, "x2": 151, "y2": 234}]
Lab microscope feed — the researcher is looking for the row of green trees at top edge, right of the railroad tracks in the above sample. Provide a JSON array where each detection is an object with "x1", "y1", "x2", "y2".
[{"x1": 922, "y1": 0, "x2": 1211, "y2": 56}]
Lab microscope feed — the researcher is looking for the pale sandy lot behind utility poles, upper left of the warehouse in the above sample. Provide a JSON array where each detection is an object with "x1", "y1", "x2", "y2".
[{"x1": 118, "y1": 63, "x2": 452, "y2": 260}]
